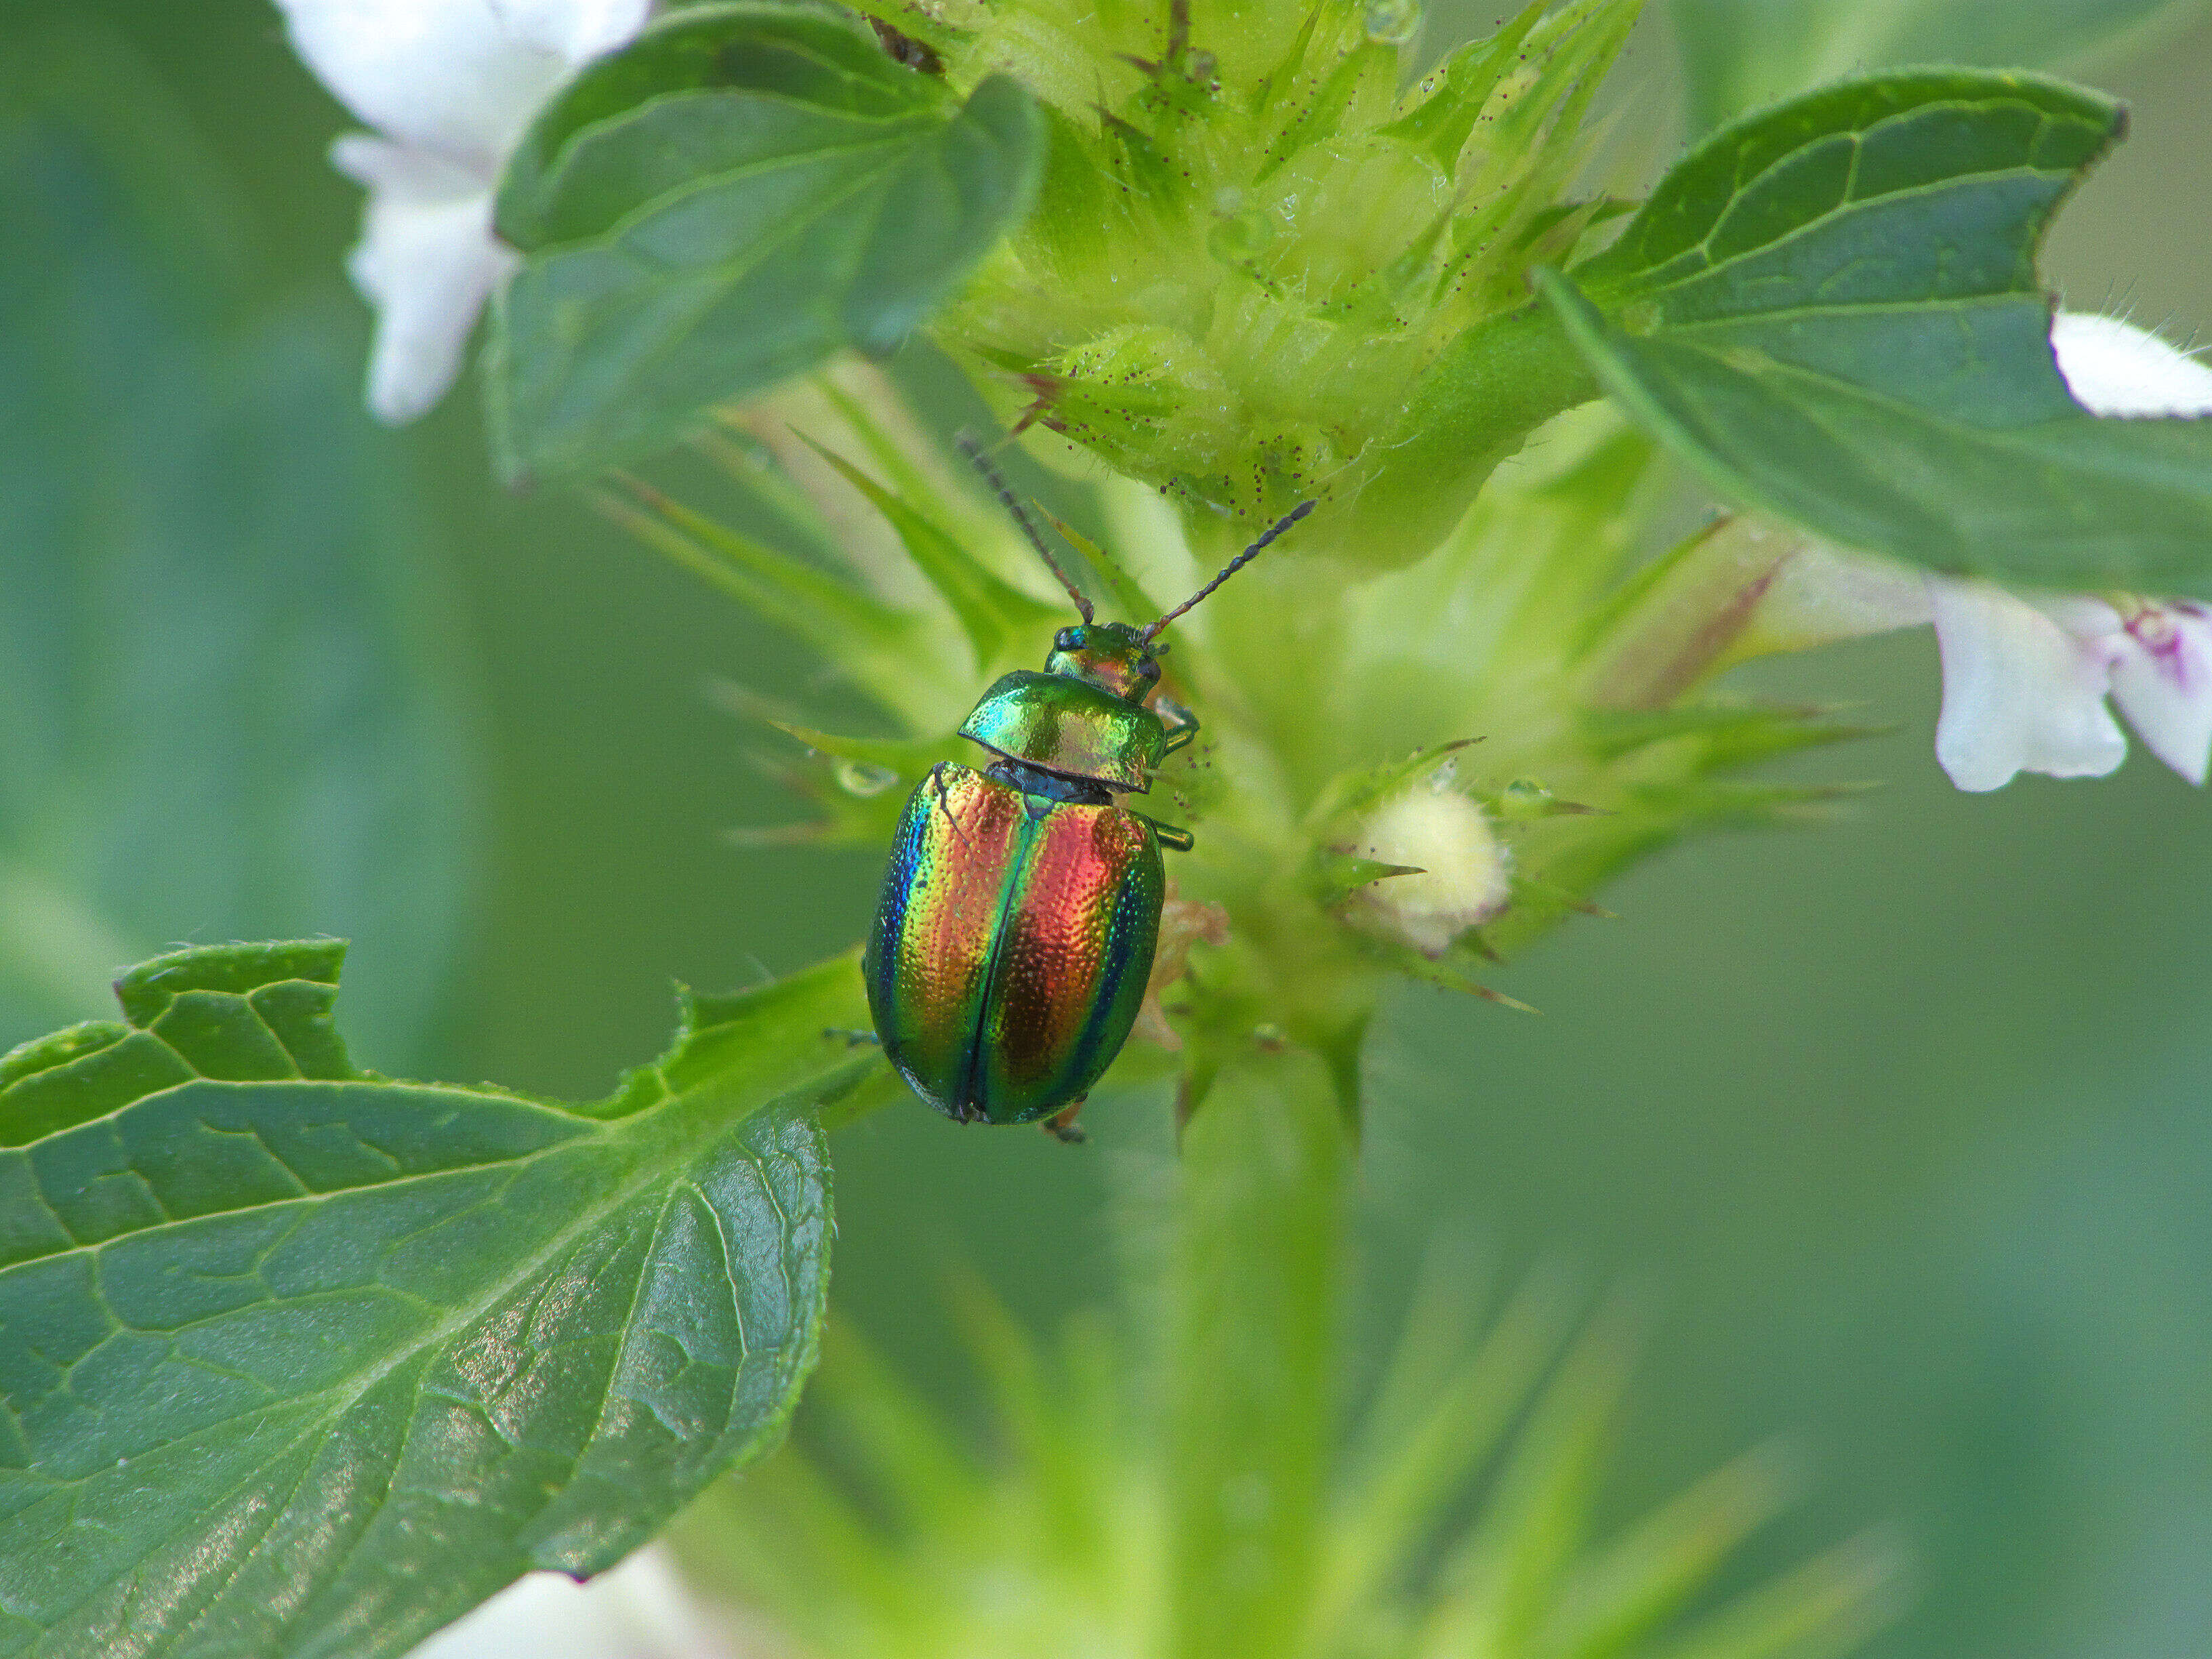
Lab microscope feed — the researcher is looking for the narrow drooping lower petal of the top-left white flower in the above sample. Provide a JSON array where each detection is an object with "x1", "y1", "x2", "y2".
[{"x1": 329, "y1": 133, "x2": 516, "y2": 425}]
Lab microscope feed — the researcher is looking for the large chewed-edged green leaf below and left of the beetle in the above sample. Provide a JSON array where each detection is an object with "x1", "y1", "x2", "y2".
[{"x1": 0, "y1": 942, "x2": 878, "y2": 1659}]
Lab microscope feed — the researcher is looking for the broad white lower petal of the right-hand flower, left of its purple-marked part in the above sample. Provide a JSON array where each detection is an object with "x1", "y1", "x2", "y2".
[{"x1": 1929, "y1": 577, "x2": 2128, "y2": 790}]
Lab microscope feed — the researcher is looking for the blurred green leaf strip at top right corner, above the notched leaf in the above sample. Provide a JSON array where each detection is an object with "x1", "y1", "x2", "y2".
[{"x1": 1670, "y1": 0, "x2": 2207, "y2": 133}]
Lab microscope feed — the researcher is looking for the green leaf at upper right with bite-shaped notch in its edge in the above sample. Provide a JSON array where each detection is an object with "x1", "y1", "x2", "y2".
[{"x1": 1540, "y1": 70, "x2": 2212, "y2": 595}]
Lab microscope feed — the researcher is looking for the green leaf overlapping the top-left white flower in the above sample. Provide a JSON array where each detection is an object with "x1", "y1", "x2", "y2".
[{"x1": 491, "y1": 2, "x2": 1042, "y2": 476}]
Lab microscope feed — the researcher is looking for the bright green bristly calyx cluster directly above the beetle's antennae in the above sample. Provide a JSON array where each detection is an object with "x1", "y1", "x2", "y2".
[{"x1": 920, "y1": 0, "x2": 1637, "y2": 569}]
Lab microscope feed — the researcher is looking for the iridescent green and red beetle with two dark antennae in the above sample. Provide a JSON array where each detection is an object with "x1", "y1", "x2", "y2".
[{"x1": 863, "y1": 438, "x2": 1314, "y2": 1139}]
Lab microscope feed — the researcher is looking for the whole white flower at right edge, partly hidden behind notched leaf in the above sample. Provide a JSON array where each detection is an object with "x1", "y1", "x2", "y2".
[{"x1": 1759, "y1": 312, "x2": 2212, "y2": 790}]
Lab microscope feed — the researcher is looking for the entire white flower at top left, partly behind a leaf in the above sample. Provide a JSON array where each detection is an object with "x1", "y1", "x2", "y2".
[{"x1": 276, "y1": 0, "x2": 653, "y2": 422}]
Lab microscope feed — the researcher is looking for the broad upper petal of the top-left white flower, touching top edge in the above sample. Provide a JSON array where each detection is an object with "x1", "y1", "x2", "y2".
[{"x1": 276, "y1": 0, "x2": 575, "y2": 170}]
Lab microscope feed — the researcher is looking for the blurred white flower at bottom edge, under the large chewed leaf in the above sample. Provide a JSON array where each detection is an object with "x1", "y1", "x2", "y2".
[{"x1": 409, "y1": 1544, "x2": 739, "y2": 1659}]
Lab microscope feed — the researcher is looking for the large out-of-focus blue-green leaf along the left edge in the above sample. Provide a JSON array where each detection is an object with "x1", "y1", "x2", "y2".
[{"x1": 0, "y1": 28, "x2": 476, "y2": 1066}]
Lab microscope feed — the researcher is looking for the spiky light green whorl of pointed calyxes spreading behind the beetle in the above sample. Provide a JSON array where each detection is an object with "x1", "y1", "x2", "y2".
[{"x1": 668, "y1": 383, "x2": 1862, "y2": 1115}]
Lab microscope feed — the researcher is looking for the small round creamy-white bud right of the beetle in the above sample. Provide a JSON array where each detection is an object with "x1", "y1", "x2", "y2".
[{"x1": 1347, "y1": 783, "x2": 1511, "y2": 956}]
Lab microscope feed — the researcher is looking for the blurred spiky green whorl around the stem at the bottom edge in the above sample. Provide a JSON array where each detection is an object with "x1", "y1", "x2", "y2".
[{"x1": 672, "y1": 1256, "x2": 1898, "y2": 1659}]
